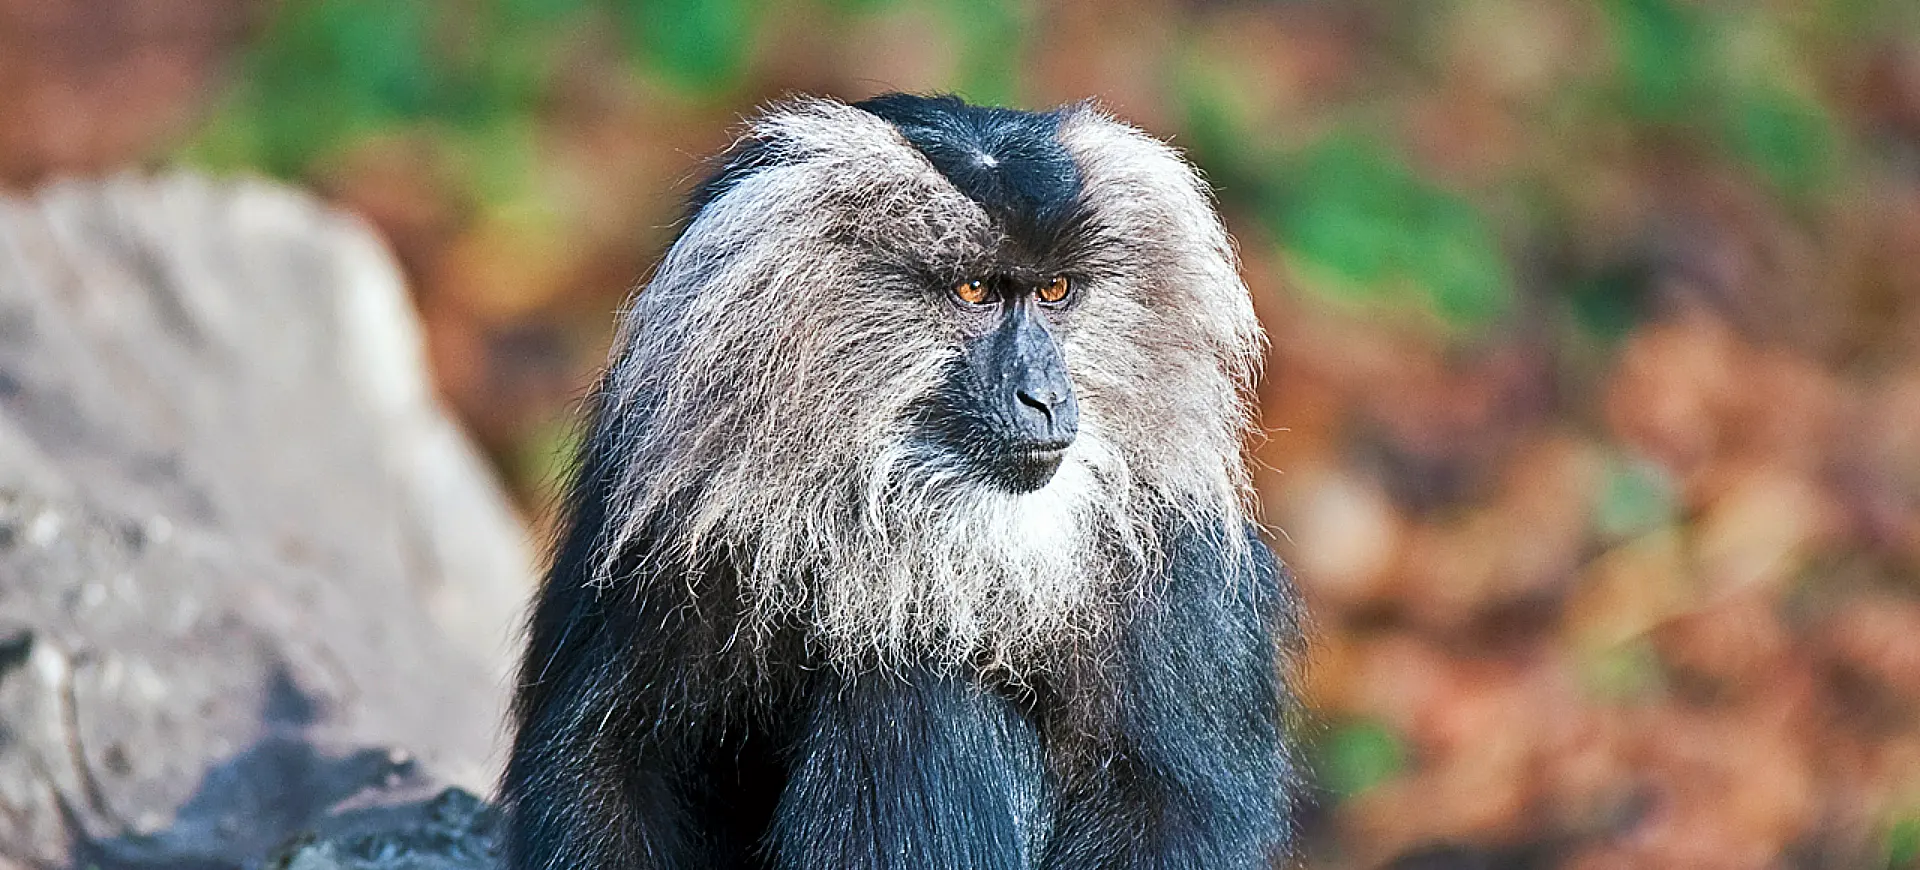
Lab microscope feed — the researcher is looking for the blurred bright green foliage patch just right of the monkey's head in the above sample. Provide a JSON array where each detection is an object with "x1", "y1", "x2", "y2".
[{"x1": 1267, "y1": 136, "x2": 1513, "y2": 328}]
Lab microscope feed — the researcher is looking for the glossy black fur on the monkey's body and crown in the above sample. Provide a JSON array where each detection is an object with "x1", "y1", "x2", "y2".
[{"x1": 501, "y1": 98, "x2": 1298, "y2": 870}]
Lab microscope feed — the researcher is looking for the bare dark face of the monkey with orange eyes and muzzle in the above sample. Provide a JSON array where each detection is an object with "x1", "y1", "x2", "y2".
[{"x1": 941, "y1": 277, "x2": 1079, "y2": 492}]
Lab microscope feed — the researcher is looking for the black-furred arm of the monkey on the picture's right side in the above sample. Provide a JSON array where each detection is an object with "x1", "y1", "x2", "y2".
[{"x1": 1039, "y1": 528, "x2": 1298, "y2": 868}]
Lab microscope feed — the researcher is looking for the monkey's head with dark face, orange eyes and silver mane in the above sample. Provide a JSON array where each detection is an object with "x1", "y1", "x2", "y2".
[{"x1": 595, "y1": 94, "x2": 1261, "y2": 657}]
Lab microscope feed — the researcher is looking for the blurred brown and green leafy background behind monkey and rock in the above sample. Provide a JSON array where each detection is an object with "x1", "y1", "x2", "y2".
[{"x1": 0, "y1": 0, "x2": 1920, "y2": 868}]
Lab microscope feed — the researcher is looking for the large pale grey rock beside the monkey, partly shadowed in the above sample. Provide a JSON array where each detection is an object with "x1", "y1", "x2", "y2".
[{"x1": 0, "y1": 175, "x2": 532, "y2": 868}]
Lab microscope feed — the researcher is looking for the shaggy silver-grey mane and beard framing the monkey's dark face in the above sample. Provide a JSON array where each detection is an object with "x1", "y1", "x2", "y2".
[{"x1": 595, "y1": 100, "x2": 1263, "y2": 663}]
